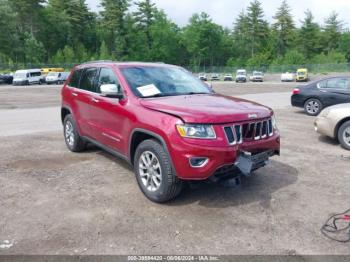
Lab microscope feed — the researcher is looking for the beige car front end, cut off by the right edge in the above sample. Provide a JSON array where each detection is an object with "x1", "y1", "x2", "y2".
[{"x1": 315, "y1": 103, "x2": 350, "y2": 150}]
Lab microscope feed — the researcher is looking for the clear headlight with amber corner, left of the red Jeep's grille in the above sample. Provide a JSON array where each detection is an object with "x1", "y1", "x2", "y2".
[{"x1": 176, "y1": 124, "x2": 216, "y2": 139}]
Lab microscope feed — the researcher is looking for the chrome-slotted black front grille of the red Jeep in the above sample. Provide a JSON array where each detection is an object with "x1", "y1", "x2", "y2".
[{"x1": 224, "y1": 119, "x2": 273, "y2": 145}]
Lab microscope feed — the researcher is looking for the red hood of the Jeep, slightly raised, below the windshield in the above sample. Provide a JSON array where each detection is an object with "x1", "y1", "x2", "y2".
[{"x1": 140, "y1": 94, "x2": 272, "y2": 124}]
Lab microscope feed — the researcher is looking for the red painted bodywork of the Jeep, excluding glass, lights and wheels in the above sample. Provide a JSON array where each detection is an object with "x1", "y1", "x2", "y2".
[{"x1": 62, "y1": 62, "x2": 280, "y2": 180}]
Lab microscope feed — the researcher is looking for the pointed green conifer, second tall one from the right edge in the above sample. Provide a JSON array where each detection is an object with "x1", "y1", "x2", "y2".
[{"x1": 298, "y1": 10, "x2": 321, "y2": 59}]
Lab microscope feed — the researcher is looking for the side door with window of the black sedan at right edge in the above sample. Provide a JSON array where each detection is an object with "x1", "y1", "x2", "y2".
[{"x1": 319, "y1": 77, "x2": 350, "y2": 106}]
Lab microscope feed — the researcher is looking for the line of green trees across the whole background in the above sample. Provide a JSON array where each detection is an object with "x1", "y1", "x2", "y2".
[{"x1": 0, "y1": 0, "x2": 350, "y2": 67}]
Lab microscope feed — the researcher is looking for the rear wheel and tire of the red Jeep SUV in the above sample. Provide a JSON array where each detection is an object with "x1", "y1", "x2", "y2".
[{"x1": 63, "y1": 115, "x2": 86, "y2": 152}]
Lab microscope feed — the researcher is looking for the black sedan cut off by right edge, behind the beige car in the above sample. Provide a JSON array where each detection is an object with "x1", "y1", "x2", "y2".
[{"x1": 291, "y1": 77, "x2": 350, "y2": 116}]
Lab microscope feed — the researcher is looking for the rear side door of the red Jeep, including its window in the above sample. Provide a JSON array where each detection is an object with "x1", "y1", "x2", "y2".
[{"x1": 69, "y1": 67, "x2": 98, "y2": 138}]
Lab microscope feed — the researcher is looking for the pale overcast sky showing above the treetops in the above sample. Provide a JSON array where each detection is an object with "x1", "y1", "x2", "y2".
[{"x1": 87, "y1": 0, "x2": 350, "y2": 28}]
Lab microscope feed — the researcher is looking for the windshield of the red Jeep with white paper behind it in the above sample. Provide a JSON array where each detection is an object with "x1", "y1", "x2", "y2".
[{"x1": 121, "y1": 66, "x2": 211, "y2": 97}]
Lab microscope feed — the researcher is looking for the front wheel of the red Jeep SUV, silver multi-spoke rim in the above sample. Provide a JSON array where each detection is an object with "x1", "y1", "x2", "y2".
[{"x1": 134, "y1": 139, "x2": 183, "y2": 203}]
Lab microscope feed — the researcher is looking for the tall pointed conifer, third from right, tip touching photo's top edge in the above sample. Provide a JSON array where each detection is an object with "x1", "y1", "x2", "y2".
[{"x1": 273, "y1": 0, "x2": 295, "y2": 55}]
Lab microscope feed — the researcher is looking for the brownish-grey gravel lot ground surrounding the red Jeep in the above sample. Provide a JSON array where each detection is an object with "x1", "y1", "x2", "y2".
[{"x1": 0, "y1": 83, "x2": 350, "y2": 255}]
